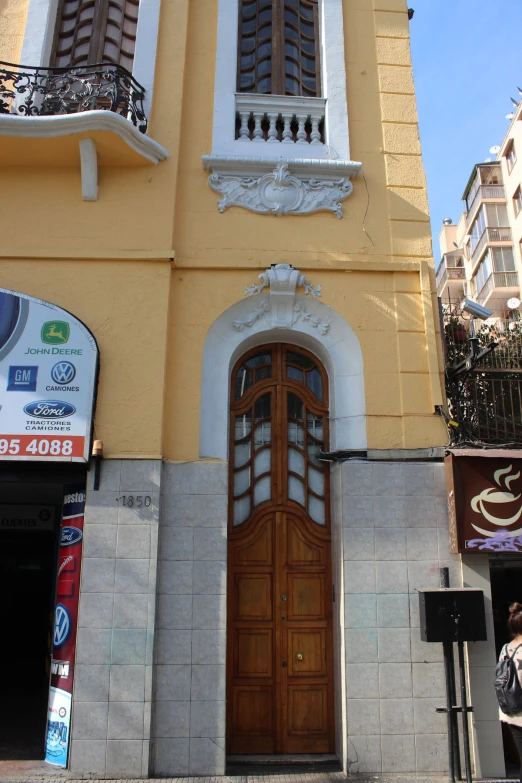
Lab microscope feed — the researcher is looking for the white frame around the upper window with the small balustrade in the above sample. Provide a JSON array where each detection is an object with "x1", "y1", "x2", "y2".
[{"x1": 212, "y1": 0, "x2": 350, "y2": 161}]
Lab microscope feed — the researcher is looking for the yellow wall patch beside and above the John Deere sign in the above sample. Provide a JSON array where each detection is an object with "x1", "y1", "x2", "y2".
[{"x1": 0, "y1": 260, "x2": 170, "y2": 457}]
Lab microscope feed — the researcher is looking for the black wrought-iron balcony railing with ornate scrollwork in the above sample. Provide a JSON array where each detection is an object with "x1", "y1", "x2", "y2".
[{"x1": 0, "y1": 61, "x2": 147, "y2": 133}]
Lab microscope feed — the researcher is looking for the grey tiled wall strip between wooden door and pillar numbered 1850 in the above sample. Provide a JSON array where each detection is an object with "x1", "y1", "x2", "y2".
[{"x1": 149, "y1": 462, "x2": 224, "y2": 777}]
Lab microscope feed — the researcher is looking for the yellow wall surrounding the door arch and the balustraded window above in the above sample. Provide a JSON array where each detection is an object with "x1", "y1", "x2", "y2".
[{"x1": 161, "y1": 0, "x2": 446, "y2": 460}]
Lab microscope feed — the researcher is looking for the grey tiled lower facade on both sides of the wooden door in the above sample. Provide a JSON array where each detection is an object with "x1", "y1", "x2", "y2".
[{"x1": 71, "y1": 460, "x2": 503, "y2": 778}]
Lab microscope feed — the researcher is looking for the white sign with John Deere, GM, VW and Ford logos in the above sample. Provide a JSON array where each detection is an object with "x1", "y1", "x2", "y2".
[{"x1": 0, "y1": 288, "x2": 98, "y2": 462}]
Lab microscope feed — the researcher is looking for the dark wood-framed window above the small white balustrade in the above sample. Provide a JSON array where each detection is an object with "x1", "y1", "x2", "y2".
[{"x1": 237, "y1": 0, "x2": 321, "y2": 98}]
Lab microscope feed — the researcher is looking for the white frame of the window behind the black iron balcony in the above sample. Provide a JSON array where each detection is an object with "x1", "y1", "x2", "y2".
[{"x1": 20, "y1": 0, "x2": 161, "y2": 117}]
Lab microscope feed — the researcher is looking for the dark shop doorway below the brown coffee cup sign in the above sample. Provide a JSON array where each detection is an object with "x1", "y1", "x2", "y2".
[{"x1": 489, "y1": 555, "x2": 522, "y2": 777}]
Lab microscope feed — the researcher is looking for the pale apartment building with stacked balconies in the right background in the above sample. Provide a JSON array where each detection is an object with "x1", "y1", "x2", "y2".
[{"x1": 437, "y1": 102, "x2": 522, "y2": 318}]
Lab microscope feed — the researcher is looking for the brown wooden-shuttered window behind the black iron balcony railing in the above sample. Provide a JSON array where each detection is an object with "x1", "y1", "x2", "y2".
[{"x1": 51, "y1": 0, "x2": 139, "y2": 71}]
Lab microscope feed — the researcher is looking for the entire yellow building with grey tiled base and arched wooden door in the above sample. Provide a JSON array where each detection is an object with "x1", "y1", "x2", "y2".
[{"x1": 0, "y1": 0, "x2": 504, "y2": 778}]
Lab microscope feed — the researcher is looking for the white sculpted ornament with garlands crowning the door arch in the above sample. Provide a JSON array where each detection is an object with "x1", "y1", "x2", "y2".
[{"x1": 233, "y1": 264, "x2": 330, "y2": 335}]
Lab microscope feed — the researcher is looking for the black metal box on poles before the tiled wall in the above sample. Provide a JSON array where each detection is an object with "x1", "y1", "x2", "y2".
[{"x1": 419, "y1": 587, "x2": 487, "y2": 642}]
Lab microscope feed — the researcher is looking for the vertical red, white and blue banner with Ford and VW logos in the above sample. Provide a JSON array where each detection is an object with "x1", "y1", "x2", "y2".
[{"x1": 45, "y1": 485, "x2": 85, "y2": 767}]
